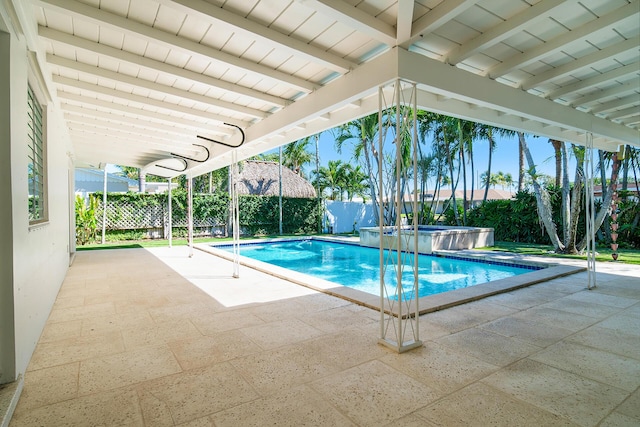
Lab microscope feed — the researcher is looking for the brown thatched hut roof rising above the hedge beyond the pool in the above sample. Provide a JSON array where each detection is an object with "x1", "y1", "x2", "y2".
[{"x1": 237, "y1": 160, "x2": 316, "y2": 199}]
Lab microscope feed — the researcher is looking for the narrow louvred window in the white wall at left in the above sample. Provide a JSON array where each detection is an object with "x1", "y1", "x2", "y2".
[{"x1": 27, "y1": 85, "x2": 47, "y2": 224}]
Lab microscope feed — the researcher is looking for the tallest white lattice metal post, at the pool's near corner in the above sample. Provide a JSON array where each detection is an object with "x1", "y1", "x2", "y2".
[{"x1": 377, "y1": 79, "x2": 422, "y2": 353}]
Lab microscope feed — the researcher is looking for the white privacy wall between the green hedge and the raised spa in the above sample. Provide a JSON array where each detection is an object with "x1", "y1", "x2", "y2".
[{"x1": 323, "y1": 200, "x2": 377, "y2": 233}]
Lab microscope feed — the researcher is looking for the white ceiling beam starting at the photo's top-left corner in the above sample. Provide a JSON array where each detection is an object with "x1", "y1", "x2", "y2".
[{"x1": 34, "y1": 0, "x2": 317, "y2": 92}]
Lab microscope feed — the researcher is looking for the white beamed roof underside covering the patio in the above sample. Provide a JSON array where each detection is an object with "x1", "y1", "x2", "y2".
[{"x1": 20, "y1": 0, "x2": 640, "y2": 175}]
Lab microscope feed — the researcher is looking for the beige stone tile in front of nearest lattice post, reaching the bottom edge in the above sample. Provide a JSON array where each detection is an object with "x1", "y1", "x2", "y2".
[{"x1": 310, "y1": 360, "x2": 437, "y2": 426}]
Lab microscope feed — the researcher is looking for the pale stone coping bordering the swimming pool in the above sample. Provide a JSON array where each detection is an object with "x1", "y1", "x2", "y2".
[{"x1": 194, "y1": 236, "x2": 586, "y2": 317}]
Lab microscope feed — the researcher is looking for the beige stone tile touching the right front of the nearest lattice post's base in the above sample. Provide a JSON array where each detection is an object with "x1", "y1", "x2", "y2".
[{"x1": 379, "y1": 341, "x2": 498, "y2": 395}]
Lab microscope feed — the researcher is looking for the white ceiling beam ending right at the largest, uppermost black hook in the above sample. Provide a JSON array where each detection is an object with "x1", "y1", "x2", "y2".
[{"x1": 57, "y1": 90, "x2": 234, "y2": 136}]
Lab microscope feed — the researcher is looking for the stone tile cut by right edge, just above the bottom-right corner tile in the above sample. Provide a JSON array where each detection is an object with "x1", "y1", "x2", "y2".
[{"x1": 529, "y1": 342, "x2": 640, "y2": 391}]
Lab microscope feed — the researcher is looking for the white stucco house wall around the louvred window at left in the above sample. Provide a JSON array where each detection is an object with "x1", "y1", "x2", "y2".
[{"x1": 0, "y1": 6, "x2": 73, "y2": 382}]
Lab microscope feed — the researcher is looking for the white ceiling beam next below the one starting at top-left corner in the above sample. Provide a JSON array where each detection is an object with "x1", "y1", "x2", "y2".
[{"x1": 38, "y1": 26, "x2": 290, "y2": 107}]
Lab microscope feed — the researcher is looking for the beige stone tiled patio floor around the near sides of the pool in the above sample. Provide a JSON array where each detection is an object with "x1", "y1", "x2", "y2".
[{"x1": 10, "y1": 247, "x2": 640, "y2": 427}]
